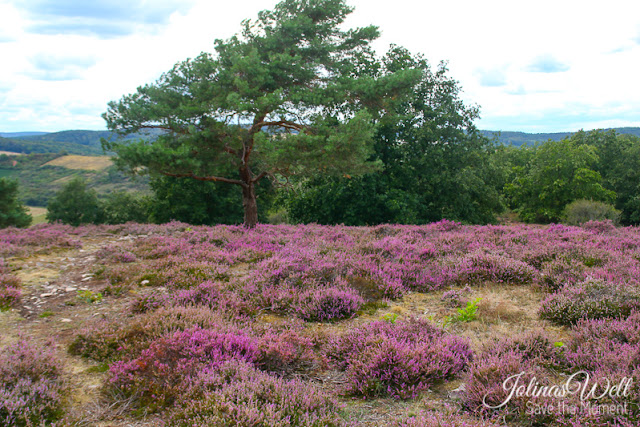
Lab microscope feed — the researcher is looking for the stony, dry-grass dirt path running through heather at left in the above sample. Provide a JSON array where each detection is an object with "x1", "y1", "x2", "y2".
[{"x1": 0, "y1": 234, "x2": 162, "y2": 427}]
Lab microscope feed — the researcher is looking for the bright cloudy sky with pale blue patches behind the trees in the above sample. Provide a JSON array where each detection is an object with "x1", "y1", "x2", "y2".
[{"x1": 0, "y1": 0, "x2": 640, "y2": 132}]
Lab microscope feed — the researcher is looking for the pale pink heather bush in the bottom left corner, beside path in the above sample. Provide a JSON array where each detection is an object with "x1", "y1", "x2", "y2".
[{"x1": 0, "y1": 338, "x2": 65, "y2": 426}]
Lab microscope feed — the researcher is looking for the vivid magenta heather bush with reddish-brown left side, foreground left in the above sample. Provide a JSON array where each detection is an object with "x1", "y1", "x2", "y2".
[{"x1": 109, "y1": 328, "x2": 257, "y2": 409}]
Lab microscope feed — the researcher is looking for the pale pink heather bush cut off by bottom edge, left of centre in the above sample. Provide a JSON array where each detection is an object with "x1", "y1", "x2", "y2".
[{"x1": 168, "y1": 361, "x2": 344, "y2": 427}]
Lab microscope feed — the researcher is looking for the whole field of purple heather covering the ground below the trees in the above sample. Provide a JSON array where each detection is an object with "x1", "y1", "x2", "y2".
[{"x1": 0, "y1": 220, "x2": 640, "y2": 427}]
